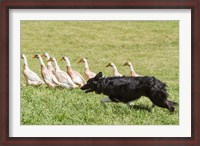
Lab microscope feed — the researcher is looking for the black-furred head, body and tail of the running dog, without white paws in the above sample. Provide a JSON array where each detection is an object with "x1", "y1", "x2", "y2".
[{"x1": 81, "y1": 72, "x2": 175, "y2": 112}]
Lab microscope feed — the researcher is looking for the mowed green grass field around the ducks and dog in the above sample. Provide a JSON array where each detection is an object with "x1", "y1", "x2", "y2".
[{"x1": 21, "y1": 21, "x2": 179, "y2": 125}]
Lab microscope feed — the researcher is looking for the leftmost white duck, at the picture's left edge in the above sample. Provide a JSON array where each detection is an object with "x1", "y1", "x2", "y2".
[{"x1": 21, "y1": 54, "x2": 44, "y2": 86}]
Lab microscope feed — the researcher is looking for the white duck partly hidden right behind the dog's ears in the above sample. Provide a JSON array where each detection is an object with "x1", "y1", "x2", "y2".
[{"x1": 78, "y1": 58, "x2": 96, "y2": 80}]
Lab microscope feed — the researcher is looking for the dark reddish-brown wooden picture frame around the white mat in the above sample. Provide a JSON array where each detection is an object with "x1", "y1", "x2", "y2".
[{"x1": 0, "y1": 0, "x2": 200, "y2": 146}]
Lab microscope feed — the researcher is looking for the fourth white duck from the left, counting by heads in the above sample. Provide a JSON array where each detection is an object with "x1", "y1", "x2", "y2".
[{"x1": 48, "y1": 57, "x2": 78, "y2": 88}]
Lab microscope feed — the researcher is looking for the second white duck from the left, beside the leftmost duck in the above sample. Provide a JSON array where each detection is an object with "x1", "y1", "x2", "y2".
[{"x1": 33, "y1": 54, "x2": 61, "y2": 87}]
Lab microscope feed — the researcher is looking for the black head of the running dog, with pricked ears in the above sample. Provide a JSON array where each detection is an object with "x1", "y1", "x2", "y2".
[{"x1": 81, "y1": 72, "x2": 103, "y2": 93}]
